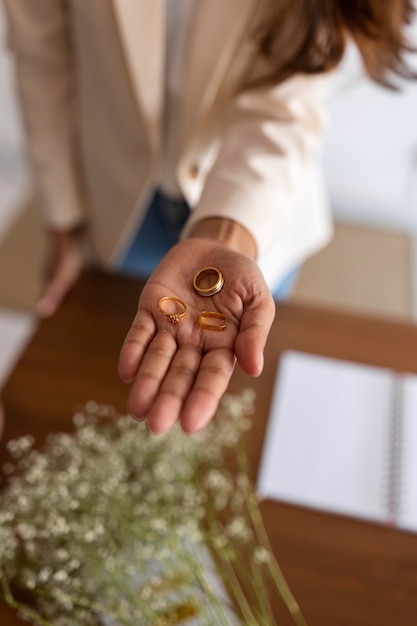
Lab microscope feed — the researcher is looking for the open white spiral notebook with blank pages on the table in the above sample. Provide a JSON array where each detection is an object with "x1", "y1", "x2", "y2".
[{"x1": 258, "y1": 352, "x2": 417, "y2": 531}]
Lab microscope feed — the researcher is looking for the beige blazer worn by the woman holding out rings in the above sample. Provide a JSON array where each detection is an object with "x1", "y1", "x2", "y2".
[{"x1": 5, "y1": 0, "x2": 331, "y2": 284}]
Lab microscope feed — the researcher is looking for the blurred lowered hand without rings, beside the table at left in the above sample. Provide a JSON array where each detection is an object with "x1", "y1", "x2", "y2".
[{"x1": 36, "y1": 229, "x2": 84, "y2": 317}]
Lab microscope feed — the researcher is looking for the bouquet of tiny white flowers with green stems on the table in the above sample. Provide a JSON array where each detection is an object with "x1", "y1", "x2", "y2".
[{"x1": 0, "y1": 390, "x2": 305, "y2": 626}]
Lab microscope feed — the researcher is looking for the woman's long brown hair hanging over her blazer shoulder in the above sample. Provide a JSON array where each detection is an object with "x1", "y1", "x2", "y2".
[{"x1": 249, "y1": 0, "x2": 417, "y2": 88}]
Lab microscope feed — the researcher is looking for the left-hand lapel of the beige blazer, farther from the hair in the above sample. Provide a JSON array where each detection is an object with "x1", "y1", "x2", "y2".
[{"x1": 113, "y1": 0, "x2": 165, "y2": 152}]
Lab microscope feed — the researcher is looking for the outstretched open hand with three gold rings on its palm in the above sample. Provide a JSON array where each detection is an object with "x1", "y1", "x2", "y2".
[{"x1": 119, "y1": 238, "x2": 275, "y2": 433}]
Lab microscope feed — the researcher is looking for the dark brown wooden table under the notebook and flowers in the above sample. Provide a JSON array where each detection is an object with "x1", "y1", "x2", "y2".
[{"x1": 0, "y1": 272, "x2": 417, "y2": 626}]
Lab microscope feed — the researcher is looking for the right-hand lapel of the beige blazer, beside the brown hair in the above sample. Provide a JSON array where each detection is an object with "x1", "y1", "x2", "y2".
[{"x1": 183, "y1": 0, "x2": 257, "y2": 139}]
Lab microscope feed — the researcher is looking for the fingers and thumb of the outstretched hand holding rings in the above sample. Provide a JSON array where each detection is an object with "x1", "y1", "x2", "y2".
[{"x1": 119, "y1": 299, "x2": 275, "y2": 434}]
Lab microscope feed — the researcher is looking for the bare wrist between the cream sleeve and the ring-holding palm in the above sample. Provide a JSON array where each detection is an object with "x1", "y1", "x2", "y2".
[{"x1": 188, "y1": 217, "x2": 257, "y2": 259}]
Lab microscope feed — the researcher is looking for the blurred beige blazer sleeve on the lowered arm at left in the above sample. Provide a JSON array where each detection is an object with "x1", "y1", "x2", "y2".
[{"x1": 4, "y1": 0, "x2": 85, "y2": 230}]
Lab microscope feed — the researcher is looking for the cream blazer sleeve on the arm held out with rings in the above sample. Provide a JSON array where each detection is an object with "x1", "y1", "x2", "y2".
[{"x1": 183, "y1": 73, "x2": 333, "y2": 257}]
